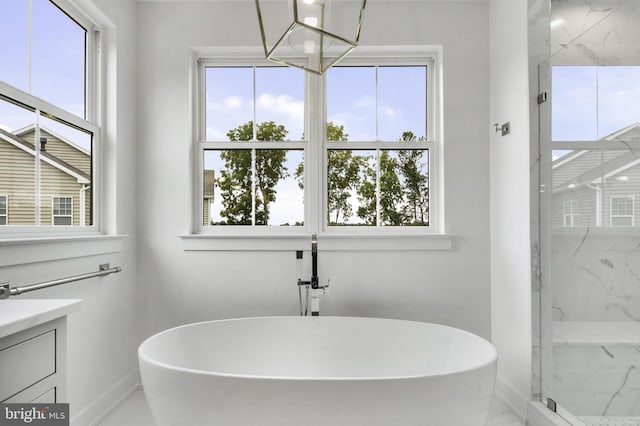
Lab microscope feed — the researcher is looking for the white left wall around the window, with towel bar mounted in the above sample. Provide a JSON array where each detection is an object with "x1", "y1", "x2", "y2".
[{"x1": 0, "y1": 0, "x2": 140, "y2": 425}]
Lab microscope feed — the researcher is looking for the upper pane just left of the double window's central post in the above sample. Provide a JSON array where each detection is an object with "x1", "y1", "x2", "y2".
[{"x1": 256, "y1": 67, "x2": 304, "y2": 140}]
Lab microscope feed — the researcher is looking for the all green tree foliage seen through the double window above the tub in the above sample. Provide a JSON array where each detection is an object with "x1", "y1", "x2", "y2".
[{"x1": 216, "y1": 121, "x2": 429, "y2": 226}]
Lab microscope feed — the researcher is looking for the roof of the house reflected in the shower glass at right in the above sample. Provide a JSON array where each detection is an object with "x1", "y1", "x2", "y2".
[{"x1": 552, "y1": 123, "x2": 640, "y2": 192}]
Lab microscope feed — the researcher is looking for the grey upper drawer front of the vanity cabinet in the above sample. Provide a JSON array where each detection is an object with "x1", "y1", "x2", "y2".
[{"x1": 0, "y1": 330, "x2": 56, "y2": 401}]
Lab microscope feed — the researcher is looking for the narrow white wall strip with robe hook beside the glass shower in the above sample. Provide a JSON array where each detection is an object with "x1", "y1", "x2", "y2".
[{"x1": 489, "y1": 0, "x2": 532, "y2": 417}]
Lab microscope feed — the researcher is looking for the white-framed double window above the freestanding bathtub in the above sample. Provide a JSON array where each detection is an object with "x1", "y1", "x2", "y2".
[{"x1": 196, "y1": 53, "x2": 436, "y2": 233}]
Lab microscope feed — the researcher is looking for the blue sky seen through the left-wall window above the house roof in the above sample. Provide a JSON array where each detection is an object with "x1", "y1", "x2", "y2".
[{"x1": 0, "y1": 0, "x2": 91, "y2": 150}]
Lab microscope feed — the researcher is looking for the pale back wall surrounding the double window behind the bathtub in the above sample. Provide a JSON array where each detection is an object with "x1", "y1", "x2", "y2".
[{"x1": 137, "y1": 1, "x2": 491, "y2": 338}]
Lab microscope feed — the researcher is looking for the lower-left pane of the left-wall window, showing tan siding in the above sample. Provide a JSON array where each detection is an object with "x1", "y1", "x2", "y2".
[{"x1": 0, "y1": 98, "x2": 36, "y2": 225}]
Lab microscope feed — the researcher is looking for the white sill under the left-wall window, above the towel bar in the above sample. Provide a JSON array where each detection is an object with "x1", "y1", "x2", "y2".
[{"x1": 0, "y1": 235, "x2": 126, "y2": 267}]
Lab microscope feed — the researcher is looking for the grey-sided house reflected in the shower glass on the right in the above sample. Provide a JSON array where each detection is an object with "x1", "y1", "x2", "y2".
[{"x1": 551, "y1": 123, "x2": 640, "y2": 227}]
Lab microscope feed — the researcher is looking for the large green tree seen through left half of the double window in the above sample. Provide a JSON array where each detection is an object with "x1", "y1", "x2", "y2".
[{"x1": 216, "y1": 121, "x2": 289, "y2": 225}]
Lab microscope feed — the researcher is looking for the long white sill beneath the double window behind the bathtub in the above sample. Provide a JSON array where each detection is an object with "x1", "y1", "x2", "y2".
[{"x1": 179, "y1": 234, "x2": 454, "y2": 251}]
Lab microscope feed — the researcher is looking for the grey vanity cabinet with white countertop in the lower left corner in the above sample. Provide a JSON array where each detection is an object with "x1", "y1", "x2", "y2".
[{"x1": 0, "y1": 300, "x2": 79, "y2": 403}]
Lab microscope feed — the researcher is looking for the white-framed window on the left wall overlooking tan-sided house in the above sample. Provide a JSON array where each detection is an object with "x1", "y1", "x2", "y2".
[{"x1": 0, "y1": 0, "x2": 100, "y2": 232}]
